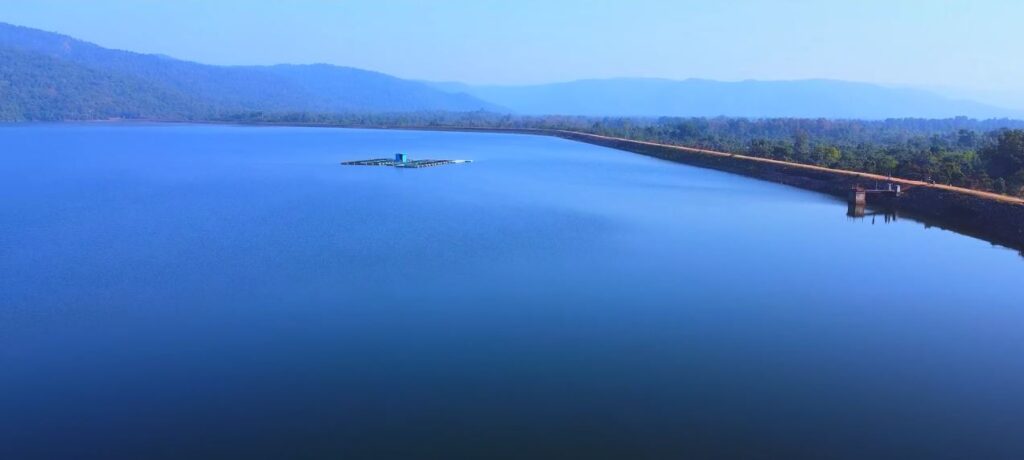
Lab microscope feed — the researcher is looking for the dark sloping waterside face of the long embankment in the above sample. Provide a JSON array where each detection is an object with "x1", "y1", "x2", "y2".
[{"x1": 68, "y1": 120, "x2": 1024, "y2": 256}]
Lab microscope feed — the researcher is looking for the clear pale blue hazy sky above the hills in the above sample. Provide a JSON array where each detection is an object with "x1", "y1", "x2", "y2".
[{"x1": 0, "y1": 0, "x2": 1024, "y2": 93}]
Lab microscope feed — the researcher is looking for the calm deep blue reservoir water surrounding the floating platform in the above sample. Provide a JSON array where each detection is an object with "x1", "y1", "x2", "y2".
[{"x1": 0, "y1": 125, "x2": 1024, "y2": 459}]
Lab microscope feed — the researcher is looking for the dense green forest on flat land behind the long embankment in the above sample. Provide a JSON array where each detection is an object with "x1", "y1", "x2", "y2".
[{"x1": 220, "y1": 112, "x2": 1024, "y2": 196}]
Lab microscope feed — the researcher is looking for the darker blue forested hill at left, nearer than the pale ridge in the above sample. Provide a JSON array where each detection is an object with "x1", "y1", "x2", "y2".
[{"x1": 0, "y1": 23, "x2": 499, "y2": 120}]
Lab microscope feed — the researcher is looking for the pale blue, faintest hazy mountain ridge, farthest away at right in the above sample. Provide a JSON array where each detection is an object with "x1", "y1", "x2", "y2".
[{"x1": 433, "y1": 78, "x2": 1024, "y2": 119}]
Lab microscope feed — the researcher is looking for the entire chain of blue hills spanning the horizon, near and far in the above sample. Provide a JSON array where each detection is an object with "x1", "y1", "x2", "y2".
[{"x1": 0, "y1": 23, "x2": 1024, "y2": 120}]
